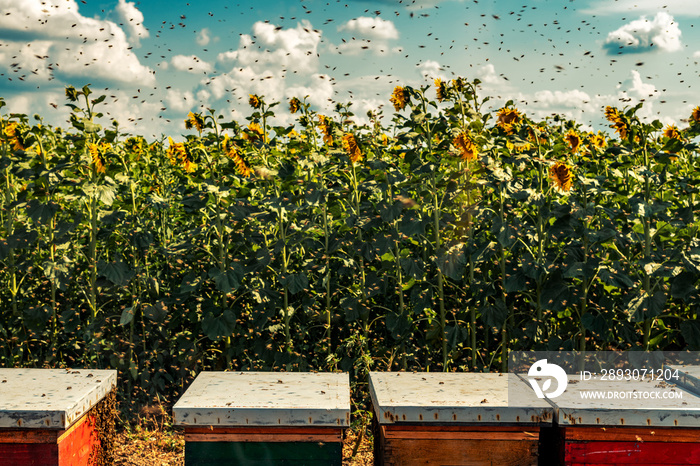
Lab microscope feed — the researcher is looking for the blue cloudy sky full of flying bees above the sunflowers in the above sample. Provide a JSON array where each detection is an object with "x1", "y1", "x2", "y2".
[{"x1": 0, "y1": 0, "x2": 700, "y2": 138}]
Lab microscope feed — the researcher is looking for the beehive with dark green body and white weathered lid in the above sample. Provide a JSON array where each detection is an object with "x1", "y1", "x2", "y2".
[{"x1": 173, "y1": 372, "x2": 350, "y2": 466}]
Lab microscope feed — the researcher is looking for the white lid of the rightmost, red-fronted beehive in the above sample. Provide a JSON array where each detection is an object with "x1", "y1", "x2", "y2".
[{"x1": 549, "y1": 375, "x2": 700, "y2": 427}]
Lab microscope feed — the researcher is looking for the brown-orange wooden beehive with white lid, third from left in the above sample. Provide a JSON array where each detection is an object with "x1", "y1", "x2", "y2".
[{"x1": 370, "y1": 372, "x2": 552, "y2": 466}]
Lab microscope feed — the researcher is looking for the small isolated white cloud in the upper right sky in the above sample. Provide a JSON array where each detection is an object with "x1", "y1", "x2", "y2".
[{"x1": 604, "y1": 11, "x2": 681, "y2": 54}]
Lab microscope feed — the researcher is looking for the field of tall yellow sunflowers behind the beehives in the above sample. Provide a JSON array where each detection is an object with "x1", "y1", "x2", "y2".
[{"x1": 0, "y1": 78, "x2": 700, "y2": 412}]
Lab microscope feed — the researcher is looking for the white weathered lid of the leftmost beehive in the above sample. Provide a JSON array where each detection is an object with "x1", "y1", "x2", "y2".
[{"x1": 0, "y1": 368, "x2": 117, "y2": 429}]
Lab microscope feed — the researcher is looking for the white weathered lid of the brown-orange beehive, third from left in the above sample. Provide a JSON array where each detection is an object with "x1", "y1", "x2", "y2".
[{"x1": 370, "y1": 372, "x2": 552, "y2": 424}]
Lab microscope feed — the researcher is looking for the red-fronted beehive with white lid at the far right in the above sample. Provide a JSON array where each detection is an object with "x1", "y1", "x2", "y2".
[{"x1": 550, "y1": 375, "x2": 700, "y2": 466}]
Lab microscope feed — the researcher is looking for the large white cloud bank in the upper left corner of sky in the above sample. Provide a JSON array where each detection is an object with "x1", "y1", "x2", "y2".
[{"x1": 0, "y1": 0, "x2": 155, "y2": 85}]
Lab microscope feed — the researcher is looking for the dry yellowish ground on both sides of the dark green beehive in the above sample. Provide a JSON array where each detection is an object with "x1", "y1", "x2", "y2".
[{"x1": 114, "y1": 422, "x2": 374, "y2": 466}]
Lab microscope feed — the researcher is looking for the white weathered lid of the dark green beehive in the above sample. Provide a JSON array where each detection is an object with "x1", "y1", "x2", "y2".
[{"x1": 173, "y1": 372, "x2": 350, "y2": 427}]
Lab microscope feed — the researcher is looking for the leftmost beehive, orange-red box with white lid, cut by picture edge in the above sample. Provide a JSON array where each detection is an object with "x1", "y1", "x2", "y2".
[{"x1": 0, "y1": 369, "x2": 117, "y2": 466}]
